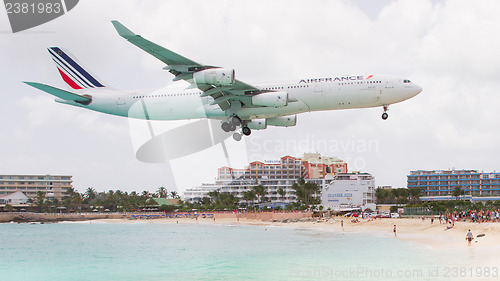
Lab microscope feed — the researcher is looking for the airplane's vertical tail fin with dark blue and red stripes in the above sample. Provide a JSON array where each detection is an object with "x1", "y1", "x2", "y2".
[{"x1": 47, "y1": 47, "x2": 106, "y2": 90}]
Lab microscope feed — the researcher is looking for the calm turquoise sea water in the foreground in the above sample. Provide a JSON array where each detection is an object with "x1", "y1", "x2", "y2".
[{"x1": 0, "y1": 222, "x2": 495, "y2": 281}]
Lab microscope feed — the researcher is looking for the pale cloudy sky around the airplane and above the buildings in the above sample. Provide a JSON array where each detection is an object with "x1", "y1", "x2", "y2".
[{"x1": 0, "y1": 0, "x2": 500, "y2": 192}]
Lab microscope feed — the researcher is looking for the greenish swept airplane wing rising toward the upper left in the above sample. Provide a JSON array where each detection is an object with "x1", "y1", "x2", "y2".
[{"x1": 111, "y1": 20, "x2": 262, "y2": 110}]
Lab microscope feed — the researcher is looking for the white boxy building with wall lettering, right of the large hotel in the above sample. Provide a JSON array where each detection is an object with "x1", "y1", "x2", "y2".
[{"x1": 321, "y1": 172, "x2": 376, "y2": 211}]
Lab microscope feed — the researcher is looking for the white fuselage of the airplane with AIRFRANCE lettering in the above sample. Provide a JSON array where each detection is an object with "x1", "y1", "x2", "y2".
[{"x1": 57, "y1": 75, "x2": 422, "y2": 120}]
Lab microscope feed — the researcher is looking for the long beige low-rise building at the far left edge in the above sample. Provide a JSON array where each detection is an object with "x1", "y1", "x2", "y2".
[{"x1": 0, "y1": 175, "x2": 73, "y2": 200}]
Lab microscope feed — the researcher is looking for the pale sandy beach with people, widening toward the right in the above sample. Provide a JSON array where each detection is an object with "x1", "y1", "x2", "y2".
[{"x1": 93, "y1": 214, "x2": 500, "y2": 249}]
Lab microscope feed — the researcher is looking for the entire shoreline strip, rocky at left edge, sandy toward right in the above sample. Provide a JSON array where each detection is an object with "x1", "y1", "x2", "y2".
[{"x1": 4, "y1": 212, "x2": 500, "y2": 253}]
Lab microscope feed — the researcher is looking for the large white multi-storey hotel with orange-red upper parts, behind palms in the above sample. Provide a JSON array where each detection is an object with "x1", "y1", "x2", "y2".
[{"x1": 183, "y1": 153, "x2": 347, "y2": 203}]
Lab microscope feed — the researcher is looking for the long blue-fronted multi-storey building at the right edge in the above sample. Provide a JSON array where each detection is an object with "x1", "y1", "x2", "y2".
[{"x1": 408, "y1": 170, "x2": 500, "y2": 201}]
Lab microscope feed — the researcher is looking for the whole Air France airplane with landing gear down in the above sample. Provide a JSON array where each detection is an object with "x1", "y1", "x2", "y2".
[{"x1": 24, "y1": 20, "x2": 422, "y2": 141}]
